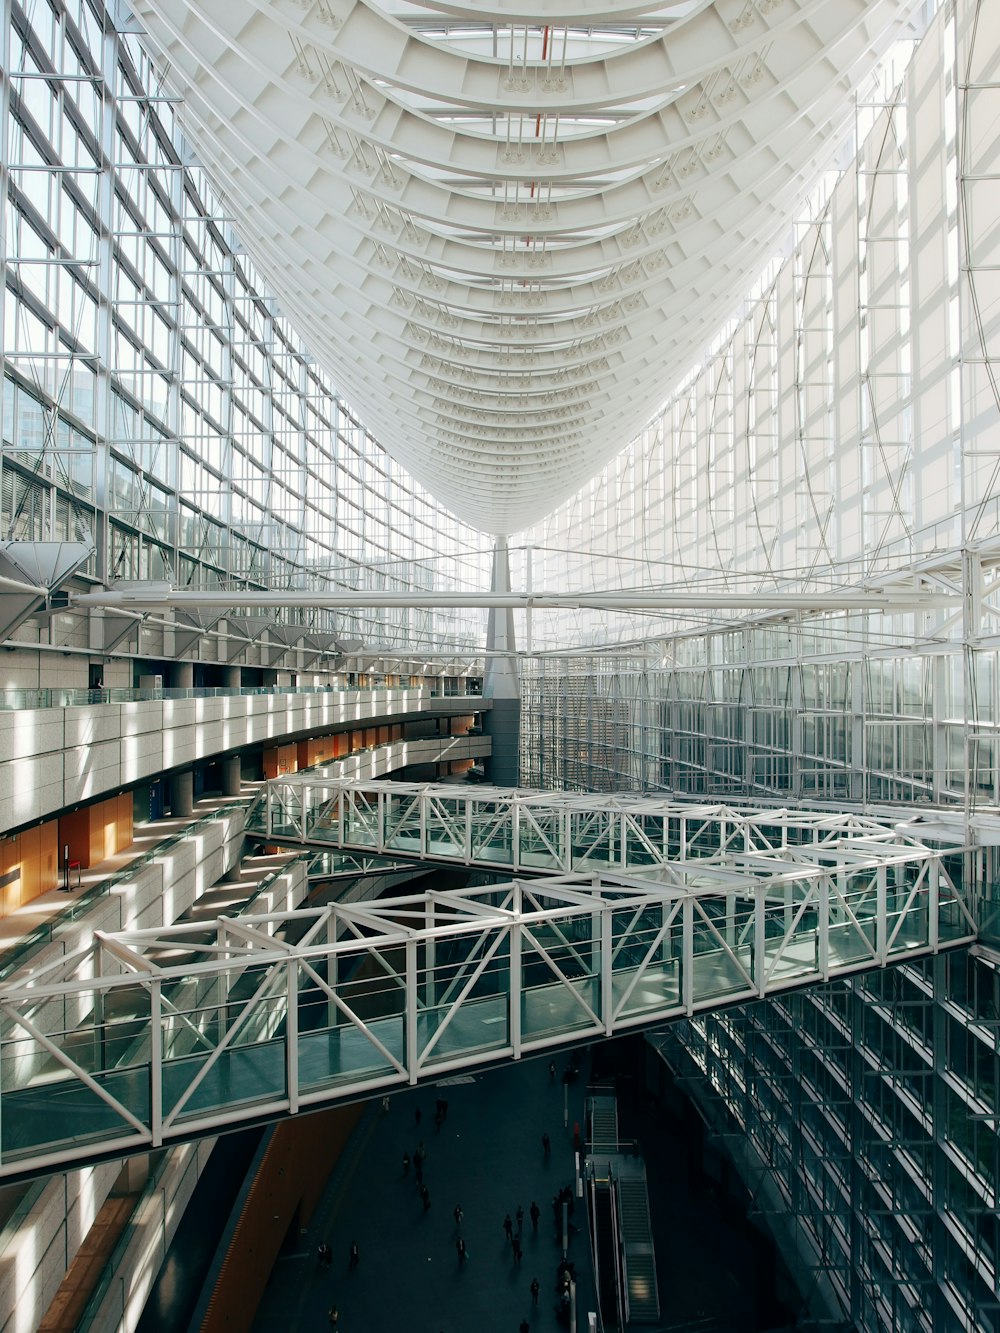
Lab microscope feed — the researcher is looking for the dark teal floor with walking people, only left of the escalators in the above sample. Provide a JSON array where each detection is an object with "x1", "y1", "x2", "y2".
[{"x1": 253, "y1": 1056, "x2": 595, "y2": 1333}]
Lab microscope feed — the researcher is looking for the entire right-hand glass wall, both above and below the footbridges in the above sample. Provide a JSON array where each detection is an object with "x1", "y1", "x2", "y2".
[{"x1": 512, "y1": 0, "x2": 1000, "y2": 1333}]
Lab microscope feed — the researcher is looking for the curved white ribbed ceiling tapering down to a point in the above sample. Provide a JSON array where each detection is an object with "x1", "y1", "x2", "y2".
[{"x1": 132, "y1": 0, "x2": 919, "y2": 533}]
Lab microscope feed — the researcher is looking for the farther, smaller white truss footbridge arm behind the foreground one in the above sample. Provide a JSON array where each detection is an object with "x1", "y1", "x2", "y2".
[{"x1": 247, "y1": 773, "x2": 963, "y2": 874}]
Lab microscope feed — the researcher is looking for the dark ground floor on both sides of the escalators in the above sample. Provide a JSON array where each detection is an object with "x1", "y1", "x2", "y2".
[{"x1": 246, "y1": 1040, "x2": 783, "y2": 1333}]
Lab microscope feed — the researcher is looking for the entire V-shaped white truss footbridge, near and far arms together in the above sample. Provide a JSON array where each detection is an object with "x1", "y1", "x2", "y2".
[{"x1": 0, "y1": 780, "x2": 976, "y2": 1178}]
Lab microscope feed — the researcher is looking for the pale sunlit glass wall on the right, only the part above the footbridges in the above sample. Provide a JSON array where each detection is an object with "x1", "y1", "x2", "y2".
[{"x1": 512, "y1": 0, "x2": 1000, "y2": 809}]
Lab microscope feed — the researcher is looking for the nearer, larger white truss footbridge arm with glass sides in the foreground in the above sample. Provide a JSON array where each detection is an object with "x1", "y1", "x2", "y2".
[{"x1": 0, "y1": 849, "x2": 975, "y2": 1178}]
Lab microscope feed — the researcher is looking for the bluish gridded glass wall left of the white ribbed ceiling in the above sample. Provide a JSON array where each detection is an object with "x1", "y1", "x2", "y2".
[{"x1": 0, "y1": 0, "x2": 488, "y2": 647}]
